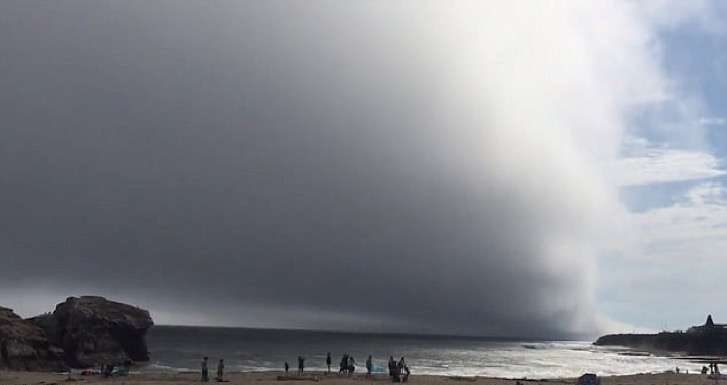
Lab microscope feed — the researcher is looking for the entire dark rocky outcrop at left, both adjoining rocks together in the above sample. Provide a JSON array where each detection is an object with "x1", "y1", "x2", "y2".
[{"x1": 0, "y1": 296, "x2": 154, "y2": 371}]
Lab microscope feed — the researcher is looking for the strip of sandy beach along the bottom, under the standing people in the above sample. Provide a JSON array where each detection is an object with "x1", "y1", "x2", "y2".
[{"x1": 0, "y1": 371, "x2": 717, "y2": 385}]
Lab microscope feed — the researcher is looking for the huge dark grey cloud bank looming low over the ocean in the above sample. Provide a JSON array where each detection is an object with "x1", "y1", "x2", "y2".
[{"x1": 0, "y1": 1, "x2": 616, "y2": 336}]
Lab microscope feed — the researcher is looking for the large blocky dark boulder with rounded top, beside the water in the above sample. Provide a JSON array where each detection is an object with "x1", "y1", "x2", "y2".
[{"x1": 33, "y1": 296, "x2": 154, "y2": 368}]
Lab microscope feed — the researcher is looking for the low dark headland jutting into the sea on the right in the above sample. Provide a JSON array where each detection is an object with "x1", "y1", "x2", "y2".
[{"x1": 594, "y1": 316, "x2": 727, "y2": 355}]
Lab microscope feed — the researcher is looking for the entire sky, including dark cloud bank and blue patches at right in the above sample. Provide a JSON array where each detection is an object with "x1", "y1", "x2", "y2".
[{"x1": 0, "y1": 0, "x2": 727, "y2": 338}]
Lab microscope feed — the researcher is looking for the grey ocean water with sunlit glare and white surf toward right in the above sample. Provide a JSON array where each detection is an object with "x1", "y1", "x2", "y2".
[{"x1": 142, "y1": 326, "x2": 701, "y2": 379}]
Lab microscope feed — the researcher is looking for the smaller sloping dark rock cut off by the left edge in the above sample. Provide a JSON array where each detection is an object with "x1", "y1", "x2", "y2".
[{"x1": 0, "y1": 307, "x2": 64, "y2": 370}]
